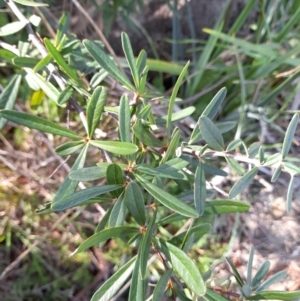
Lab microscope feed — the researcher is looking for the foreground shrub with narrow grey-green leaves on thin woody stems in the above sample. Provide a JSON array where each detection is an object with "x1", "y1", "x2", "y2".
[{"x1": 0, "y1": 0, "x2": 300, "y2": 300}]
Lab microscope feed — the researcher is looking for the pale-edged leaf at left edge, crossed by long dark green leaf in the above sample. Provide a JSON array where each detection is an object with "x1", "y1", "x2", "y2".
[{"x1": 0, "y1": 75, "x2": 22, "y2": 129}]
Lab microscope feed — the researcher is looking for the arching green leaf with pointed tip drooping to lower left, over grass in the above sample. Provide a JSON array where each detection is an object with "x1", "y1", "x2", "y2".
[{"x1": 70, "y1": 226, "x2": 139, "y2": 256}]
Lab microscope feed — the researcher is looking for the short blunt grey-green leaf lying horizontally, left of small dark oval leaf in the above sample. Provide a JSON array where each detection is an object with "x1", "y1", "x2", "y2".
[{"x1": 69, "y1": 163, "x2": 109, "y2": 182}]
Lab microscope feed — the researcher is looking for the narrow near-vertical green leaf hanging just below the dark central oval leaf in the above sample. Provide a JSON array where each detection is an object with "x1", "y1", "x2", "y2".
[{"x1": 139, "y1": 211, "x2": 156, "y2": 279}]
